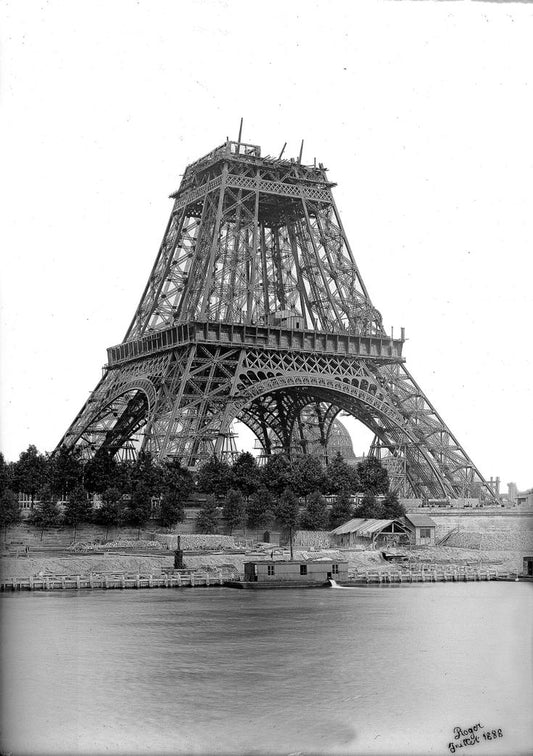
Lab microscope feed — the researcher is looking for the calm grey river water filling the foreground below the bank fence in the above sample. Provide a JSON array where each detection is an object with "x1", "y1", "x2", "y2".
[{"x1": 0, "y1": 583, "x2": 533, "y2": 756}]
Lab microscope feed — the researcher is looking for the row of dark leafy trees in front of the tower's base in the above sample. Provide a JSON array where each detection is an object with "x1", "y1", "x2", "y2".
[{"x1": 0, "y1": 446, "x2": 404, "y2": 537}]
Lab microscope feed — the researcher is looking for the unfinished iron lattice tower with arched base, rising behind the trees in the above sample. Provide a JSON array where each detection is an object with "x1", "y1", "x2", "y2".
[{"x1": 60, "y1": 140, "x2": 493, "y2": 498}]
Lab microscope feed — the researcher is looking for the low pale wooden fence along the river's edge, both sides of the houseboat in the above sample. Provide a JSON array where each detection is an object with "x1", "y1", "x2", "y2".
[{"x1": 0, "y1": 565, "x2": 519, "y2": 591}]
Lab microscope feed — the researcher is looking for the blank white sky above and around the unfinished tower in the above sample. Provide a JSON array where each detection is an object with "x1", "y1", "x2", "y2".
[{"x1": 0, "y1": 0, "x2": 533, "y2": 490}]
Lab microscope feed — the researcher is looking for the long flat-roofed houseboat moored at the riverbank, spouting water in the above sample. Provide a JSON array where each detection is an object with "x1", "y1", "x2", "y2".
[{"x1": 244, "y1": 559, "x2": 348, "y2": 587}]
